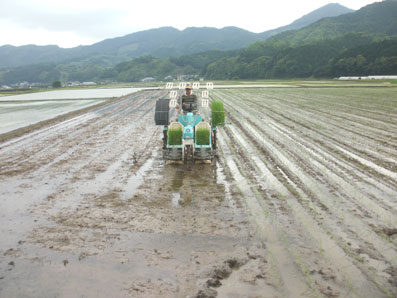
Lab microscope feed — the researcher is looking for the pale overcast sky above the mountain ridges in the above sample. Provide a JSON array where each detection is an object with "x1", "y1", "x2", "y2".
[{"x1": 0, "y1": 0, "x2": 379, "y2": 47}]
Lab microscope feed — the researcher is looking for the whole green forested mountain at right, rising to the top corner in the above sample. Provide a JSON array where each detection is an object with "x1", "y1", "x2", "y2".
[{"x1": 205, "y1": 0, "x2": 397, "y2": 79}]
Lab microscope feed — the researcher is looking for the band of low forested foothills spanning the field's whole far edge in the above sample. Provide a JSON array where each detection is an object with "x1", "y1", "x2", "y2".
[{"x1": 0, "y1": 33, "x2": 397, "y2": 84}]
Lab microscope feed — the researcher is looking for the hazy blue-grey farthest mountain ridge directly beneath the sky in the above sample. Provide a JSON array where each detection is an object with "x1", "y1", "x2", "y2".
[{"x1": 0, "y1": 4, "x2": 351, "y2": 68}]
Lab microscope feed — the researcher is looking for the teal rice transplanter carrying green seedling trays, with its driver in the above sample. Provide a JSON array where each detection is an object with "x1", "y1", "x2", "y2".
[{"x1": 155, "y1": 82, "x2": 225, "y2": 165}]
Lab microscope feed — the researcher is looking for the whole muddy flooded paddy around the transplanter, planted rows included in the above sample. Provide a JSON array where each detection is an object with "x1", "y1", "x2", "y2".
[{"x1": 0, "y1": 88, "x2": 397, "y2": 297}]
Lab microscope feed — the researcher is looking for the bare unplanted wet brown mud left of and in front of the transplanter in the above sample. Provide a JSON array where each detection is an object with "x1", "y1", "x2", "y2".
[{"x1": 0, "y1": 91, "x2": 266, "y2": 297}]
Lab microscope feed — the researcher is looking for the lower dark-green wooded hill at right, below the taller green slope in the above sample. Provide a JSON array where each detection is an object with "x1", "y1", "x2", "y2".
[{"x1": 205, "y1": 33, "x2": 397, "y2": 79}]
